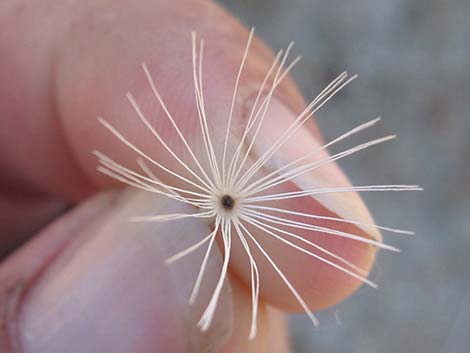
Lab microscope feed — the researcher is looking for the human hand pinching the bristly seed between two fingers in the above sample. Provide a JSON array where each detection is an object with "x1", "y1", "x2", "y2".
[{"x1": 0, "y1": 0, "x2": 375, "y2": 353}]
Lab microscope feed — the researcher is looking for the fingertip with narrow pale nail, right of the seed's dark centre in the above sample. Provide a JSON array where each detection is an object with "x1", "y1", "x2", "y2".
[{"x1": 227, "y1": 93, "x2": 382, "y2": 311}]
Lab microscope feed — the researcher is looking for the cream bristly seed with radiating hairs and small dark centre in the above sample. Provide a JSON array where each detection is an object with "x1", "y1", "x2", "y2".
[{"x1": 94, "y1": 29, "x2": 420, "y2": 339}]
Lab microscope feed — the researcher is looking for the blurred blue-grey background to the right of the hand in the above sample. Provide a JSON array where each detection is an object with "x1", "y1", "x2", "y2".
[{"x1": 219, "y1": 0, "x2": 470, "y2": 353}]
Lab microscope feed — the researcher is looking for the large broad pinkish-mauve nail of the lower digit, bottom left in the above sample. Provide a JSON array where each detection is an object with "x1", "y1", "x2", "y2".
[{"x1": 19, "y1": 190, "x2": 232, "y2": 353}]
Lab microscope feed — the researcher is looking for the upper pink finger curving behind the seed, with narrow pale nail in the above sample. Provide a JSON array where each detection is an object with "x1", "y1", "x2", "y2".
[{"x1": 52, "y1": 1, "x2": 379, "y2": 310}]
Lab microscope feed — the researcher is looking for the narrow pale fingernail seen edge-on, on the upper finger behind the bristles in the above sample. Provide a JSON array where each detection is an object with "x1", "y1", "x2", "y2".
[{"x1": 246, "y1": 99, "x2": 382, "y2": 241}]
